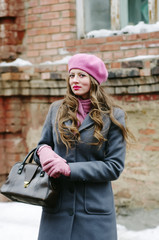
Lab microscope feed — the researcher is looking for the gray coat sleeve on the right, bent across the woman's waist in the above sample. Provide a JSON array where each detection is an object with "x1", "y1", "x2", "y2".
[{"x1": 69, "y1": 110, "x2": 126, "y2": 182}]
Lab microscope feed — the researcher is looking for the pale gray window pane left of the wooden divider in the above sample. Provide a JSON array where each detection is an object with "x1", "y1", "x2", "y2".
[{"x1": 84, "y1": 0, "x2": 111, "y2": 33}]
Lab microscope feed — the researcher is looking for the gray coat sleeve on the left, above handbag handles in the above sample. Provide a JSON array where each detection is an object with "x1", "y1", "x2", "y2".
[{"x1": 34, "y1": 105, "x2": 54, "y2": 164}]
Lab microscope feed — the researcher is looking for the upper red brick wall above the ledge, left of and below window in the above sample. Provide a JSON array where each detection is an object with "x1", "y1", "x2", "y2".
[{"x1": 0, "y1": 0, "x2": 159, "y2": 63}]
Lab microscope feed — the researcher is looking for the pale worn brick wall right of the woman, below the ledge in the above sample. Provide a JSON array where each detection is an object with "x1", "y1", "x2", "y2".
[{"x1": 113, "y1": 98, "x2": 159, "y2": 209}]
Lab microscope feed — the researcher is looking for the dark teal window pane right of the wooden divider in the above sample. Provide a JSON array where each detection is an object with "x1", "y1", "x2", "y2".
[{"x1": 128, "y1": 0, "x2": 149, "y2": 24}]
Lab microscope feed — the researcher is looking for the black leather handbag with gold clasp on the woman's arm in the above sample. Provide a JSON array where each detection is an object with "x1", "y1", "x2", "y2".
[{"x1": 1, "y1": 148, "x2": 59, "y2": 207}]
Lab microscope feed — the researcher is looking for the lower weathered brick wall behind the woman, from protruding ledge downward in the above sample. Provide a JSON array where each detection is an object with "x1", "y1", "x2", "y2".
[{"x1": 0, "y1": 59, "x2": 159, "y2": 208}]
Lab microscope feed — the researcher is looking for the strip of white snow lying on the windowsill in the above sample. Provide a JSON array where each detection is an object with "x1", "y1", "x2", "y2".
[{"x1": 86, "y1": 22, "x2": 159, "y2": 38}]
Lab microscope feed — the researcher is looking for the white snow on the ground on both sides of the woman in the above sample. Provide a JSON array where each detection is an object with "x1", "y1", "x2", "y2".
[{"x1": 0, "y1": 202, "x2": 159, "y2": 240}]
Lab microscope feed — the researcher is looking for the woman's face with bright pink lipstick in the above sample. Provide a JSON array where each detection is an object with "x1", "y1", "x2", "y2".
[{"x1": 69, "y1": 69, "x2": 91, "y2": 99}]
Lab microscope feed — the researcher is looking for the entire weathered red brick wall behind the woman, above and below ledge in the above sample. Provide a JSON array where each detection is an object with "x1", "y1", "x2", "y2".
[{"x1": 0, "y1": 0, "x2": 159, "y2": 208}]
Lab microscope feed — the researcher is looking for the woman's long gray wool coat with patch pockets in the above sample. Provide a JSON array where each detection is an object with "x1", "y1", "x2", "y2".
[{"x1": 35, "y1": 101, "x2": 125, "y2": 240}]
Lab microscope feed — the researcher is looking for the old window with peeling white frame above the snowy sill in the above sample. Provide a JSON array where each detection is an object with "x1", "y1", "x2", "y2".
[{"x1": 76, "y1": 0, "x2": 159, "y2": 38}]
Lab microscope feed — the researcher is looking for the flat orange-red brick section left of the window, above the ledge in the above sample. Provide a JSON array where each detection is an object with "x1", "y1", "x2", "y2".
[{"x1": 26, "y1": 0, "x2": 76, "y2": 63}]
